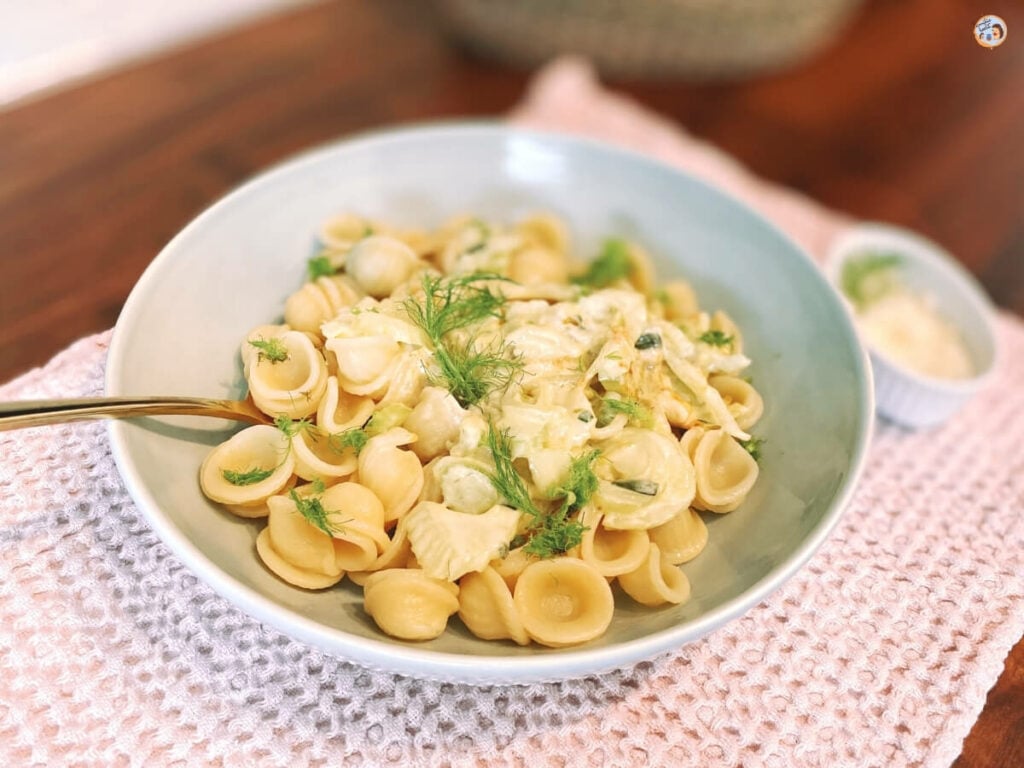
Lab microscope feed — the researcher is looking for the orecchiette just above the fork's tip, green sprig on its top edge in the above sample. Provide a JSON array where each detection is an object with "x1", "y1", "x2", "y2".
[{"x1": 246, "y1": 331, "x2": 328, "y2": 419}]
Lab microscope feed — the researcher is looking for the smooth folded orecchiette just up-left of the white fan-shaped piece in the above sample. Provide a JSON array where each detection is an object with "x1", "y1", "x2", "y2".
[{"x1": 358, "y1": 427, "x2": 423, "y2": 523}]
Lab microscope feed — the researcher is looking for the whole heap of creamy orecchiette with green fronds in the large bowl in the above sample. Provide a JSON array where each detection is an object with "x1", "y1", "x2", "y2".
[{"x1": 200, "y1": 214, "x2": 764, "y2": 647}]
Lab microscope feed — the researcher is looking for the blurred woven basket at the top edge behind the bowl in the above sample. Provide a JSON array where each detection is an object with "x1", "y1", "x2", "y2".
[{"x1": 434, "y1": 0, "x2": 862, "y2": 79}]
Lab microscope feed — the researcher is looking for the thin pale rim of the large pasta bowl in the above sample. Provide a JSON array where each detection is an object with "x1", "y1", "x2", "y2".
[{"x1": 104, "y1": 120, "x2": 874, "y2": 685}]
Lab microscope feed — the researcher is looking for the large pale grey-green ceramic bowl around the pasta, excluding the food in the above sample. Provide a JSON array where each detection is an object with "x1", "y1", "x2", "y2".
[{"x1": 108, "y1": 124, "x2": 872, "y2": 684}]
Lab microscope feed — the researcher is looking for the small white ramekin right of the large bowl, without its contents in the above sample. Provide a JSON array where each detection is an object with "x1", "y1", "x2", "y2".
[{"x1": 825, "y1": 223, "x2": 997, "y2": 428}]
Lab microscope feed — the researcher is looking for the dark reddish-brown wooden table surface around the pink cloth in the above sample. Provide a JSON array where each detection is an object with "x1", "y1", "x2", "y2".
[{"x1": 0, "y1": 0, "x2": 1024, "y2": 768}]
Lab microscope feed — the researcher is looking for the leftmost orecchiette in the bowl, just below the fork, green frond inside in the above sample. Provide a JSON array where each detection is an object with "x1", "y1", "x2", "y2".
[{"x1": 199, "y1": 425, "x2": 295, "y2": 517}]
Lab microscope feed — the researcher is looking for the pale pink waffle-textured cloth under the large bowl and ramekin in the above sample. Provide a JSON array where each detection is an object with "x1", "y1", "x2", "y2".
[{"x1": 0, "y1": 61, "x2": 1024, "y2": 768}]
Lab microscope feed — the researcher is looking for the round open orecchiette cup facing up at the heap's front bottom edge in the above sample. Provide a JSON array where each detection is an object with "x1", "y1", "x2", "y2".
[{"x1": 512, "y1": 557, "x2": 615, "y2": 648}]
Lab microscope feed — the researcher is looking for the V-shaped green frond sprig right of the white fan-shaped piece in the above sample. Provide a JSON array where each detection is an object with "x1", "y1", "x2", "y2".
[{"x1": 487, "y1": 424, "x2": 598, "y2": 558}]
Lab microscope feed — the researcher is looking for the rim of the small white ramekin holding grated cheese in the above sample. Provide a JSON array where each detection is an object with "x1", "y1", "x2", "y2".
[{"x1": 825, "y1": 221, "x2": 999, "y2": 397}]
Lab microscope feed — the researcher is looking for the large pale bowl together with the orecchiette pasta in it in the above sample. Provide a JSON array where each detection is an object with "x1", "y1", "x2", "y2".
[{"x1": 109, "y1": 126, "x2": 870, "y2": 683}]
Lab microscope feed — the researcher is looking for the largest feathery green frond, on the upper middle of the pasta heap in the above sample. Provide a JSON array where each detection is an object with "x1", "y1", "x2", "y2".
[{"x1": 404, "y1": 273, "x2": 522, "y2": 408}]
